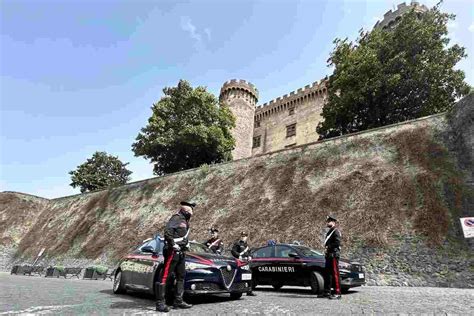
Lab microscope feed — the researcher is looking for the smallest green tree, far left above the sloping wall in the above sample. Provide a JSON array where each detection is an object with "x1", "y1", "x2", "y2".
[{"x1": 69, "y1": 151, "x2": 132, "y2": 193}]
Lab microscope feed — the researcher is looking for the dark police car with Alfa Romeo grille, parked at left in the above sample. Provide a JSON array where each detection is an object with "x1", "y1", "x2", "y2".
[{"x1": 113, "y1": 236, "x2": 252, "y2": 299}]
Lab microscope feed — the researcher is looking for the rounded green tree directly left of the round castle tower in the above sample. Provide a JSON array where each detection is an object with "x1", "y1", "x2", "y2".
[{"x1": 132, "y1": 80, "x2": 235, "y2": 175}]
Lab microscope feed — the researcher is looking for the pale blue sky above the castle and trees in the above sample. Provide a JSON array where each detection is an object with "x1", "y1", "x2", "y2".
[{"x1": 0, "y1": 0, "x2": 474, "y2": 198}]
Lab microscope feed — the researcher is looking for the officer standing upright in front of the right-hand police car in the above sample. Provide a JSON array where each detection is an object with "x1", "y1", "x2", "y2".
[{"x1": 324, "y1": 216, "x2": 342, "y2": 299}]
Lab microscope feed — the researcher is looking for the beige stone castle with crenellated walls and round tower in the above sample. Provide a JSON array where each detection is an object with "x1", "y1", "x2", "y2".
[{"x1": 219, "y1": 1, "x2": 428, "y2": 160}]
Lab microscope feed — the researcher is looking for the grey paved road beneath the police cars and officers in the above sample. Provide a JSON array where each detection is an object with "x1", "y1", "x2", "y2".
[{"x1": 0, "y1": 273, "x2": 474, "y2": 315}]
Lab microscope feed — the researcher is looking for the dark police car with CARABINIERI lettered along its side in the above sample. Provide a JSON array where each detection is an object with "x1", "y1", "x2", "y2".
[{"x1": 250, "y1": 244, "x2": 365, "y2": 294}]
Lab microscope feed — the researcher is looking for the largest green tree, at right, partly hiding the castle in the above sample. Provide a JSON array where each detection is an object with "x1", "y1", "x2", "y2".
[{"x1": 317, "y1": 4, "x2": 469, "y2": 139}]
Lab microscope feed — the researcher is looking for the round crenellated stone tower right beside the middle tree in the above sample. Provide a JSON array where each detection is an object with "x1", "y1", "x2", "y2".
[{"x1": 219, "y1": 79, "x2": 258, "y2": 160}]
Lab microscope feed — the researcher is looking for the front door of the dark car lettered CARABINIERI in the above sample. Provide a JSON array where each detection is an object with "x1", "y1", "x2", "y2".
[{"x1": 273, "y1": 245, "x2": 302, "y2": 285}]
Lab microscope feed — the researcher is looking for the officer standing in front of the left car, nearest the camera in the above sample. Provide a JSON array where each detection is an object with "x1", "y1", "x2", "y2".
[{"x1": 155, "y1": 202, "x2": 196, "y2": 312}]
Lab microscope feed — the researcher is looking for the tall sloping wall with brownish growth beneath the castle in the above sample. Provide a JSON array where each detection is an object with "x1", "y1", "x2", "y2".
[{"x1": 0, "y1": 96, "x2": 474, "y2": 288}]
